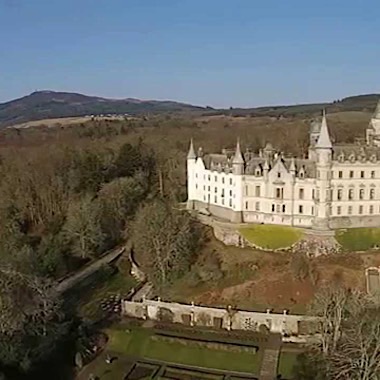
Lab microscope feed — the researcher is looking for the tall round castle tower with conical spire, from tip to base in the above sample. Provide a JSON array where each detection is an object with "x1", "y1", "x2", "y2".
[{"x1": 314, "y1": 112, "x2": 332, "y2": 230}]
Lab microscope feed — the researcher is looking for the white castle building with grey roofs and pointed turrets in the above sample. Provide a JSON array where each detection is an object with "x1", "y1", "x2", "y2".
[{"x1": 187, "y1": 102, "x2": 380, "y2": 230}]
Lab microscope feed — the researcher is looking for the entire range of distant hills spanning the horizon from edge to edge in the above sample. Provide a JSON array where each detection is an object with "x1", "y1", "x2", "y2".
[{"x1": 0, "y1": 91, "x2": 380, "y2": 128}]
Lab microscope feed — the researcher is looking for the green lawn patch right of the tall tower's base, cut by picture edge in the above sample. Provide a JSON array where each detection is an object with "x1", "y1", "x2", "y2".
[{"x1": 335, "y1": 228, "x2": 380, "y2": 251}]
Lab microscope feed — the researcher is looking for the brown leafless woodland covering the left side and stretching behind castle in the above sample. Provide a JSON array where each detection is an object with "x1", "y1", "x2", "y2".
[{"x1": 0, "y1": 109, "x2": 370, "y2": 378}]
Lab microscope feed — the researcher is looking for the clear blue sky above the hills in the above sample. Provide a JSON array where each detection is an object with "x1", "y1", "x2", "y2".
[{"x1": 0, "y1": 0, "x2": 380, "y2": 107}]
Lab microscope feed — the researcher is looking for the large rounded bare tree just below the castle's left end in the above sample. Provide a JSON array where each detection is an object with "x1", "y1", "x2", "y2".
[{"x1": 132, "y1": 199, "x2": 200, "y2": 288}]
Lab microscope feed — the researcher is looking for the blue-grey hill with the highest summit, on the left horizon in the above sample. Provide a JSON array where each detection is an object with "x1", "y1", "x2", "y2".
[{"x1": 0, "y1": 91, "x2": 206, "y2": 127}]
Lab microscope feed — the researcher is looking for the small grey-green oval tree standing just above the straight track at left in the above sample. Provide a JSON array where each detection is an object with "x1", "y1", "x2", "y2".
[{"x1": 63, "y1": 195, "x2": 104, "y2": 258}]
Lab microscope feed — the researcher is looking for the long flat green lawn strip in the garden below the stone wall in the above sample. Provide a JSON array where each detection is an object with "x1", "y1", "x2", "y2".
[{"x1": 106, "y1": 329, "x2": 261, "y2": 374}]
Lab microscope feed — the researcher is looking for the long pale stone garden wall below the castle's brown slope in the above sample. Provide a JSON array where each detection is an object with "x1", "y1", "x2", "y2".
[{"x1": 123, "y1": 300, "x2": 318, "y2": 341}]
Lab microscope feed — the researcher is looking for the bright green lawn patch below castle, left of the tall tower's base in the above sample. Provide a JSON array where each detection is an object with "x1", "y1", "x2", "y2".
[{"x1": 240, "y1": 224, "x2": 302, "y2": 249}]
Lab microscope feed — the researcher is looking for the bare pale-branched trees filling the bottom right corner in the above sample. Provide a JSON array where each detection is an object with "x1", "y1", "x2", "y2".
[{"x1": 296, "y1": 287, "x2": 380, "y2": 380}]
